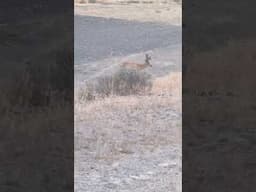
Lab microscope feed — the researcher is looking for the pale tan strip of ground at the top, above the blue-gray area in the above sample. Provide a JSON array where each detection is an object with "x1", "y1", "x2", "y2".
[{"x1": 75, "y1": 2, "x2": 182, "y2": 26}]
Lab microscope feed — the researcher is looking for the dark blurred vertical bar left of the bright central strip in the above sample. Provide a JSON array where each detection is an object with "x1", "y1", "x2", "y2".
[{"x1": 0, "y1": 0, "x2": 74, "y2": 192}]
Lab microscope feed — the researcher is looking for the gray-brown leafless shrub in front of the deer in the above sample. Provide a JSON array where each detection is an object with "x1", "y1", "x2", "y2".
[{"x1": 78, "y1": 69, "x2": 152, "y2": 101}]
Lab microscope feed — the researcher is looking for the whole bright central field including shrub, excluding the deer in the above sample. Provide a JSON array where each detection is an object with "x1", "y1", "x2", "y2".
[{"x1": 75, "y1": 3, "x2": 182, "y2": 192}]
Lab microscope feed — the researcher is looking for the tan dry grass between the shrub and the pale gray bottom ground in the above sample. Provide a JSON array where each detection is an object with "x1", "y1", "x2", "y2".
[{"x1": 75, "y1": 72, "x2": 181, "y2": 165}]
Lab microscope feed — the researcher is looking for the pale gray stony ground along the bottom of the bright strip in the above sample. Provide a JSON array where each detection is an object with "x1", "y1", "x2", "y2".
[{"x1": 75, "y1": 145, "x2": 181, "y2": 192}]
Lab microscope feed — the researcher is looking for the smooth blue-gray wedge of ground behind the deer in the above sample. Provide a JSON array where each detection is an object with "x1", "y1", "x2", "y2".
[{"x1": 74, "y1": 15, "x2": 181, "y2": 65}]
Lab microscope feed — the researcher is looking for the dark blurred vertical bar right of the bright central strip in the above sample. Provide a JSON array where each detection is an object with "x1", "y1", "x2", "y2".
[{"x1": 182, "y1": 0, "x2": 256, "y2": 192}]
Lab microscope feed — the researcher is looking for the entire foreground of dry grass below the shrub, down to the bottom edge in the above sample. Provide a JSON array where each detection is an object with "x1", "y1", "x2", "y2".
[{"x1": 75, "y1": 72, "x2": 181, "y2": 192}]
